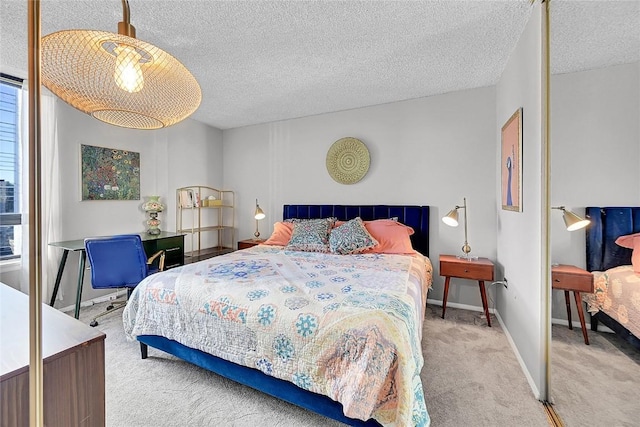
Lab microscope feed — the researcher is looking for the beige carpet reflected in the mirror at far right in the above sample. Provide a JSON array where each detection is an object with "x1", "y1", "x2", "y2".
[{"x1": 551, "y1": 325, "x2": 640, "y2": 427}]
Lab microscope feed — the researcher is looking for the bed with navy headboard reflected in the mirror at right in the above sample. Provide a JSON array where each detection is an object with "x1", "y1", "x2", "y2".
[{"x1": 582, "y1": 207, "x2": 640, "y2": 350}]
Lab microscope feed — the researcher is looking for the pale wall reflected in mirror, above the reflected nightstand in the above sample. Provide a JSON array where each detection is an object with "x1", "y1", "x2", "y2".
[{"x1": 551, "y1": 62, "x2": 640, "y2": 319}]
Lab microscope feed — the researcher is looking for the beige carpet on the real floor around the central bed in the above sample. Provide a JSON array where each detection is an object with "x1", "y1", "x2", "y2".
[{"x1": 81, "y1": 304, "x2": 549, "y2": 427}]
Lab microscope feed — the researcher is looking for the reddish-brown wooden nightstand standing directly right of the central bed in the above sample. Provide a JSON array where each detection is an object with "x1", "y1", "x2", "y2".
[{"x1": 440, "y1": 255, "x2": 494, "y2": 326}]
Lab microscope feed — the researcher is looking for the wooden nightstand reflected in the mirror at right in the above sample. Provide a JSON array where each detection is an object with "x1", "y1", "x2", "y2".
[{"x1": 551, "y1": 265, "x2": 594, "y2": 345}]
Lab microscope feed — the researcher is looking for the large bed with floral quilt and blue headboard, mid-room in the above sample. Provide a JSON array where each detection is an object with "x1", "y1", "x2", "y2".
[{"x1": 123, "y1": 205, "x2": 432, "y2": 427}]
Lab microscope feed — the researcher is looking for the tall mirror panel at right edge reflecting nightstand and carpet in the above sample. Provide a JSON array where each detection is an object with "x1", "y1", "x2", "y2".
[{"x1": 550, "y1": 0, "x2": 640, "y2": 426}]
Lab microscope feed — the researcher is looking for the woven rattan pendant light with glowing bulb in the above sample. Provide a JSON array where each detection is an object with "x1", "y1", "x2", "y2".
[{"x1": 41, "y1": 0, "x2": 202, "y2": 129}]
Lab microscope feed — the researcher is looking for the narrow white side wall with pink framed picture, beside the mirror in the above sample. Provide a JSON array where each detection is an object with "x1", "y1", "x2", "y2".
[{"x1": 493, "y1": 3, "x2": 546, "y2": 397}]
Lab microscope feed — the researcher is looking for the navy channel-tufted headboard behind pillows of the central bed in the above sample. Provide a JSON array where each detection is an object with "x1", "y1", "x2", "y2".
[{"x1": 282, "y1": 205, "x2": 429, "y2": 256}]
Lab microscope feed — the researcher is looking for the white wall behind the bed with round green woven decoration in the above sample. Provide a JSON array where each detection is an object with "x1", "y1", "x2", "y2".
[{"x1": 223, "y1": 88, "x2": 496, "y2": 307}]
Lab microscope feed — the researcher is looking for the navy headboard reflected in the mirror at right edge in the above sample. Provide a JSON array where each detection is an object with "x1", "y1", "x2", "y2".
[{"x1": 586, "y1": 207, "x2": 640, "y2": 271}]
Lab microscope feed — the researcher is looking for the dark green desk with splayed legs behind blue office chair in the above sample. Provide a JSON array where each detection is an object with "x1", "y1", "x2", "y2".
[{"x1": 49, "y1": 231, "x2": 184, "y2": 319}]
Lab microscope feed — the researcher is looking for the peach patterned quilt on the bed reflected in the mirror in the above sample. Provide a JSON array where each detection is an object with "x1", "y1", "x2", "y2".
[{"x1": 582, "y1": 265, "x2": 640, "y2": 337}]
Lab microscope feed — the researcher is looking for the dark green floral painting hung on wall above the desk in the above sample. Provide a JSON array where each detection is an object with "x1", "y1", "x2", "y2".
[{"x1": 80, "y1": 144, "x2": 140, "y2": 200}]
